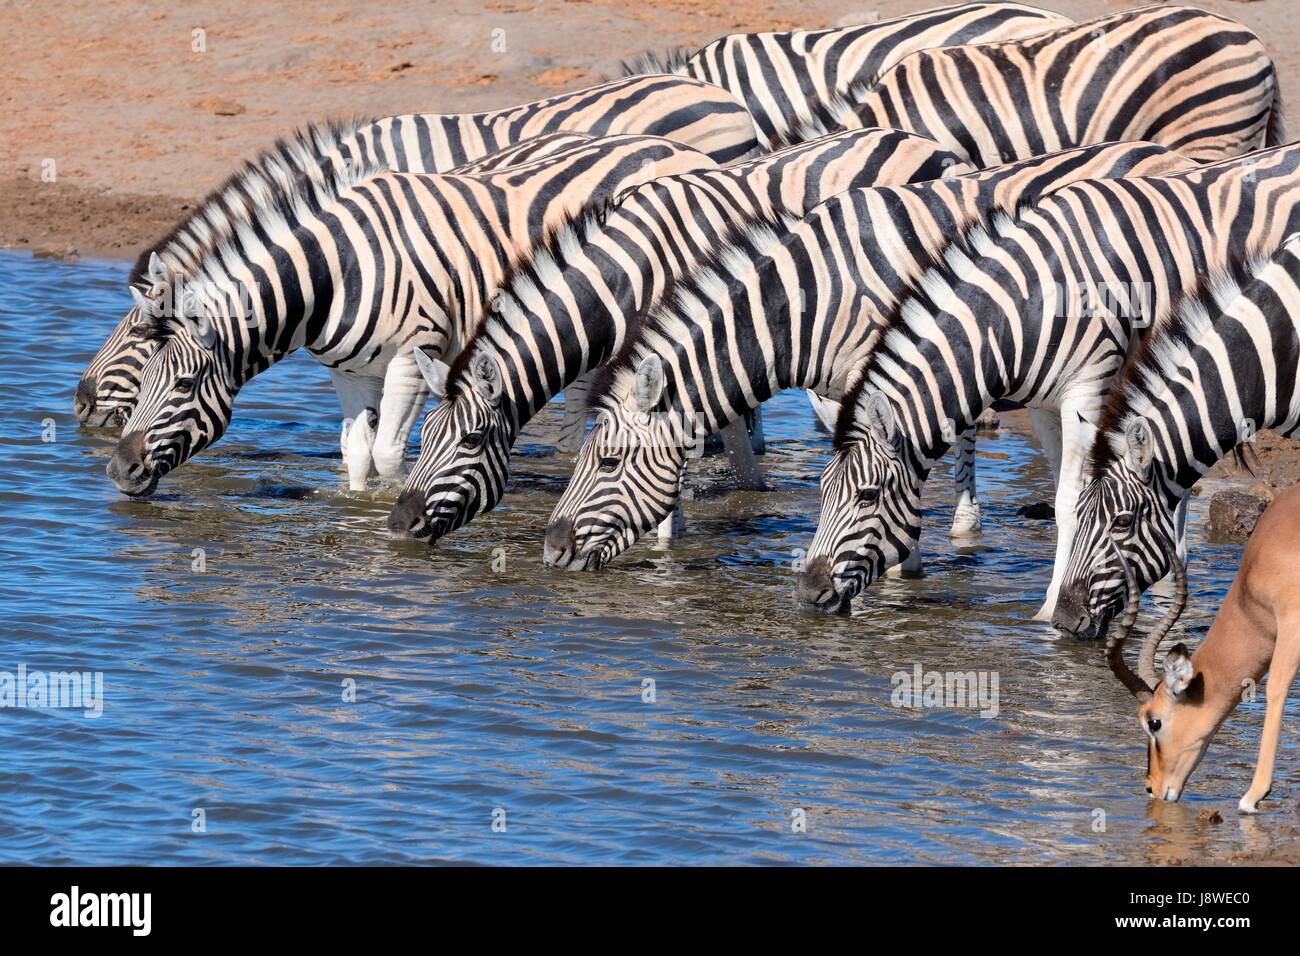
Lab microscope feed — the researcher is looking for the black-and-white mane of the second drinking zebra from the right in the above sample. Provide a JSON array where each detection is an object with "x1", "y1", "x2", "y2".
[{"x1": 833, "y1": 209, "x2": 1019, "y2": 449}]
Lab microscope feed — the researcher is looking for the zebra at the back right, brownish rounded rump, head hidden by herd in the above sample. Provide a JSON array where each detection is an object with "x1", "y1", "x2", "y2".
[{"x1": 819, "y1": 5, "x2": 1286, "y2": 168}]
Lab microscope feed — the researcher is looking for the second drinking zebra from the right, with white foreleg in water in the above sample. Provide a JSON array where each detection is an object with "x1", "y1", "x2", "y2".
[{"x1": 798, "y1": 146, "x2": 1300, "y2": 620}]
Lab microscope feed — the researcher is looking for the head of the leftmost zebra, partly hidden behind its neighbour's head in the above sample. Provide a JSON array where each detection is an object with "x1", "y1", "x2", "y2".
[{"x1": 73, "y1": 252, "x2": 168, "y2": 428}]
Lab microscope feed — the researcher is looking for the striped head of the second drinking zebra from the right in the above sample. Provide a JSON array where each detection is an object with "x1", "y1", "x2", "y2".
[{"x1": 796, "y1": 389, "x2": 924, "y2": 613}]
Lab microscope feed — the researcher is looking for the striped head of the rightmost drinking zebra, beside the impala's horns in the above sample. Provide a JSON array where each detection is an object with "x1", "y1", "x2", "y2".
[{"x1": 1052, "y1": 418, "x2": 1182, "y2": 640}]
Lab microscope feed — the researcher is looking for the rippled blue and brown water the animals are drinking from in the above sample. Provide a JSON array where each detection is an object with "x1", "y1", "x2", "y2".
[{"x1": 0, "y1": 254, "x2": 1297, "y2": 864}]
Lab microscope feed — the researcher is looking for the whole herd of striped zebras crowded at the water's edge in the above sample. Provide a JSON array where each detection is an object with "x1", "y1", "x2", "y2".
[{"x1": 74, "y1": 1, "x2": 1300, "y2": 809}]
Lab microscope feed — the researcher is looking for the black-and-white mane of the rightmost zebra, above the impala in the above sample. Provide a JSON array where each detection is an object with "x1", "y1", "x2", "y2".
[{"x1": 1088, "y1": 243, "x2": 1290, "y2": 475}]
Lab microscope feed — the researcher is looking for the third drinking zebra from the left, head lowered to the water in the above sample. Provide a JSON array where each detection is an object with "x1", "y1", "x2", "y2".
[{"x1": 389, "y1": 130, "x2": 965, "y2": 542}]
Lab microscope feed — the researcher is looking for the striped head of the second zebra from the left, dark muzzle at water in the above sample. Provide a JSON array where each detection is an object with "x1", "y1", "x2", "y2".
[{"x1": 108, "y1": 312, "x2": 232, "y2": 498}]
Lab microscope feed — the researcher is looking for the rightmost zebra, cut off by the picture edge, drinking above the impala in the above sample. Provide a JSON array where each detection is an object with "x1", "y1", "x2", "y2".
[{"x1": 1052, "y1": 234, "x2": 1300, "y2": 642}]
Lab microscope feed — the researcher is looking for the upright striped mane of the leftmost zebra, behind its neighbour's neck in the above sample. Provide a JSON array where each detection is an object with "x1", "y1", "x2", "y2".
[{"x1": 129, "y1": 117, "x2": 374, "y2": 286}]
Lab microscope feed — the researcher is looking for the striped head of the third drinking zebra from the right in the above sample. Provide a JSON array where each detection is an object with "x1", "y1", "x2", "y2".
[{"x1": 543, "y1": 354, "x2": 686, "y2": 571}]
